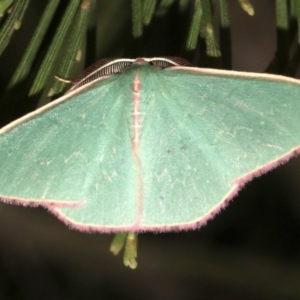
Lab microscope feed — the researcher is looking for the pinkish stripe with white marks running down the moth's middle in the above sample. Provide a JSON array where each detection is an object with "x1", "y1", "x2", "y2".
[{"x1": 132, "y1": 73, "x2": 143, "y2": 227}]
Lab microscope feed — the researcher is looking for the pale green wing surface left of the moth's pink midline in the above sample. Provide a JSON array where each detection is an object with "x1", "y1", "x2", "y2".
[{"x1": 0, "y1": 75, "x2": 136, "y2": 225}]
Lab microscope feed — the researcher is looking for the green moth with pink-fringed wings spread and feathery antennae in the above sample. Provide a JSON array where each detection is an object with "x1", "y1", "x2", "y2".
[{"x1": 0, "y1": 58, "x2": 300, "y2": 232}]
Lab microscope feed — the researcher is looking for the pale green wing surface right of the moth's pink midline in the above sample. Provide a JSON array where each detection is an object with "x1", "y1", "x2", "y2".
[{"x1": 139, "y1": 68, "x2": 300, "y2": 230}]
